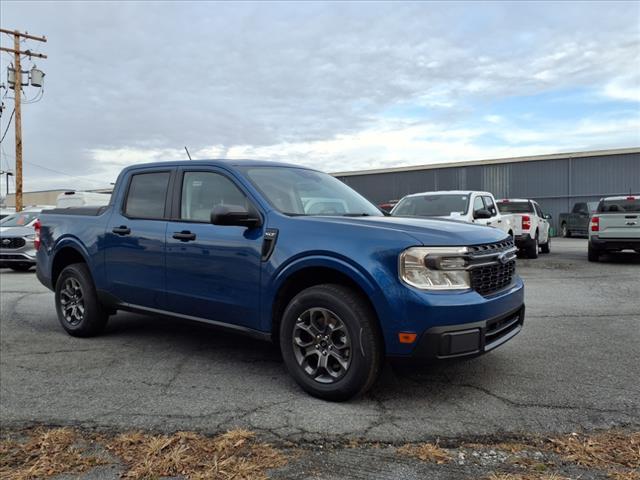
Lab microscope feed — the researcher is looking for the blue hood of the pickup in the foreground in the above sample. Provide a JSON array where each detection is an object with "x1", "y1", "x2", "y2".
[{"x1": 297, "y1": 216, "x2": 506, "y2": 247}]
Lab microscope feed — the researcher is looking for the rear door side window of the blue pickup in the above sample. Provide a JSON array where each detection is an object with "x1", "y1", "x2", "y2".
[{"x1": 124, "y1": 172, "x2": 171, "y2": 220}]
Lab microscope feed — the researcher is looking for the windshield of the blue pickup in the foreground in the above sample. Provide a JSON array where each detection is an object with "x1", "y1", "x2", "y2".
[{"x1": 242, "y1": 167, "x2": 382, "y2": 216}]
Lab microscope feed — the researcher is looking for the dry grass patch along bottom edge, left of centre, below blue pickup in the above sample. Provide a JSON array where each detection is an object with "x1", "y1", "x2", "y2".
[{"x1": 106, "y1": 430, "x2": 286, "y2": 480}]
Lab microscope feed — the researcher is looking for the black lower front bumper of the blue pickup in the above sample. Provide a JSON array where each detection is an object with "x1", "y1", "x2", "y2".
[{"x1": 412, "y1": 305, "x2": 525, "y2": 359}]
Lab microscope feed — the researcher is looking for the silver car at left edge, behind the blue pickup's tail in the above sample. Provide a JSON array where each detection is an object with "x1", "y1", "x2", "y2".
[{"x1": 0, "y1": 209, "x2": 41, "y2": 272}]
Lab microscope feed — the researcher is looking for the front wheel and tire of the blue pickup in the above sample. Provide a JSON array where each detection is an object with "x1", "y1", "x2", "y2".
[{"x1": 280, "y1": 284, "x2": 383, "y2": 401}]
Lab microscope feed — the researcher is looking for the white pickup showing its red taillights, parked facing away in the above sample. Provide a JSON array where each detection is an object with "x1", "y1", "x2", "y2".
[{"x1": 497, "y1": 198, "x2": 551, "y2": 258}]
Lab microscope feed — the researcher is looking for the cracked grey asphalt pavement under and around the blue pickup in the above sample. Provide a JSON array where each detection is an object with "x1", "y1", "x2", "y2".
[{"x1": 0, "y1": 239, "x2": 640, "y2": 443}]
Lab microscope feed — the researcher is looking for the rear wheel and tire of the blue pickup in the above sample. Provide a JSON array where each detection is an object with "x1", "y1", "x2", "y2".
[{"x1": 55, "y1": 263, "x2": 109, "y2": 337}]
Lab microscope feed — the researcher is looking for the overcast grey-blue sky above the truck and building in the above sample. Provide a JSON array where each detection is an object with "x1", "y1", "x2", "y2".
[{"x1": 0, "y1": 0, "x2": 640, "y2": 190}]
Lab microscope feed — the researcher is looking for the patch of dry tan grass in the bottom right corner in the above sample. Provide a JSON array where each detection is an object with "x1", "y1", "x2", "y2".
[{"x1": 549, "y1": 431, "x2": 640, "y2": 469}]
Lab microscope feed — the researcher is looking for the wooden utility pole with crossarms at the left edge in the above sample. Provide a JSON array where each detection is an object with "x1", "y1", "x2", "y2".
[{"x1": 0, "y1": 28, "x2": 47, "y2": 212}]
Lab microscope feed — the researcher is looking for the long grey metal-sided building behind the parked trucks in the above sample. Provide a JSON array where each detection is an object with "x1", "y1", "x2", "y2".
[{"x1": 333, "y1": 148, "x2": 640, "y2": 229}]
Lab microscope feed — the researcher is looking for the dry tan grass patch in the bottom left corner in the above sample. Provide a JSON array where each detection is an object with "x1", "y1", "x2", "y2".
[{"x1": 0, "y1": 428, "x2": 105, "y2": 480}]
